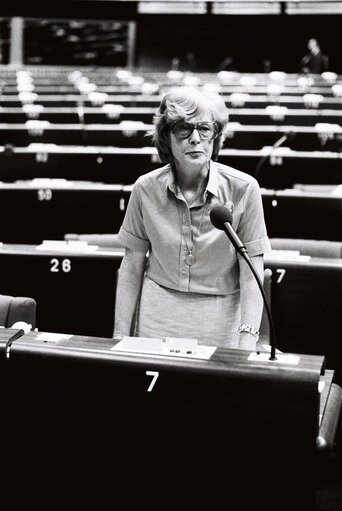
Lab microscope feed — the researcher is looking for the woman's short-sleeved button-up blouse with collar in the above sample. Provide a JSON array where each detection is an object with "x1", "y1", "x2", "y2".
[{"x1": 118, "y1": 161, "x2": 270, "y2": 295}]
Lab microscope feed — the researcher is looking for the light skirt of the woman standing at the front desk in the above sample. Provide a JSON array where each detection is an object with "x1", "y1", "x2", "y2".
[{"x1": 135, "y1": 276, "x2": 240, "y2": 348}]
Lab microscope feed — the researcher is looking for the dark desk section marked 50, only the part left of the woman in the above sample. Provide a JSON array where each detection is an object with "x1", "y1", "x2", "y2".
[{"x1": 0, "y1": 181, "x2": 130, "y2": 244}]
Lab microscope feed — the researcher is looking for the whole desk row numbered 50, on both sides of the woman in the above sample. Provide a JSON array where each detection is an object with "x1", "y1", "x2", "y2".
[{"x1": 0, "y1": 179, "x2": 342, "y2": 244}]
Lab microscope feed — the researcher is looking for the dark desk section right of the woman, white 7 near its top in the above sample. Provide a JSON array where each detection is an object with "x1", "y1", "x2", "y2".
[{"x1": 265, "y1": 252, "x2": 342, "y2": 383}]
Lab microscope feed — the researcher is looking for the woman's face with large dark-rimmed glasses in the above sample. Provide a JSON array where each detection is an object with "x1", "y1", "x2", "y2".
[{"x1": 170, "y1": 114, "x2": 214, "y2": 169}]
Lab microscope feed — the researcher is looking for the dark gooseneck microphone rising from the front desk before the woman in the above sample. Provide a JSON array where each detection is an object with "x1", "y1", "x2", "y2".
[{"x1": 210, "y1": 206, "x2": 277, "y2": 360}]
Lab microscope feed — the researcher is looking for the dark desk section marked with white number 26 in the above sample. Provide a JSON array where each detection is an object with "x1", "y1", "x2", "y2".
[{"x1": 0, "y1": 245, "x2": 122, "y2": 337}]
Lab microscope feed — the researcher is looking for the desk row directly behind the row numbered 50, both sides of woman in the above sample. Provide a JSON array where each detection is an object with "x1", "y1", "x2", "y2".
[{"x1": 0, "y1": 143, "x2": 342, "y2": 189}]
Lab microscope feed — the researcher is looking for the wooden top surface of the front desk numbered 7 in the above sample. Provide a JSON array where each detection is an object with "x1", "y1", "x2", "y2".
[{"x1": 11, "y1": 332, "x2": 325, "y2": 382}]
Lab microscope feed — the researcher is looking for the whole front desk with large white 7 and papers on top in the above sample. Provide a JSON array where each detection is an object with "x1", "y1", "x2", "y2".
[{"x1": 0, "y1": 326, "x2": 342, "y2": 511}]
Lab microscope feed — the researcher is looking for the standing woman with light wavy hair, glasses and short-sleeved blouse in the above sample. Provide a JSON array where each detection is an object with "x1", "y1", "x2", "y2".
[{"x1": 114, "y1": 87, "x2": 269, "y2": 349}]
